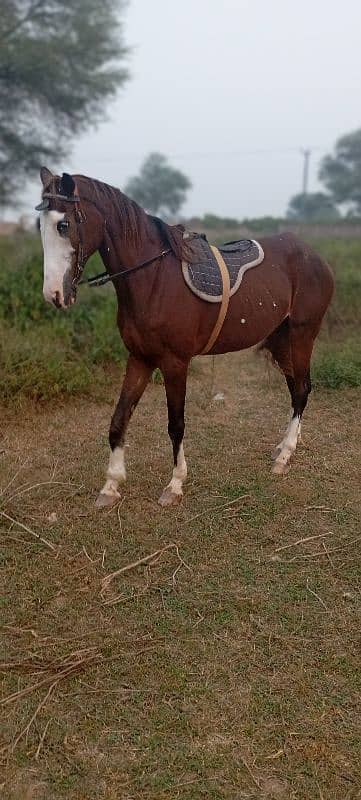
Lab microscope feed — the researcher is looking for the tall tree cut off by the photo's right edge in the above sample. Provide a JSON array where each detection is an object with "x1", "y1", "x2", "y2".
[{"x1": 319, "y1": 129, "x2": 361, "y2": 214}]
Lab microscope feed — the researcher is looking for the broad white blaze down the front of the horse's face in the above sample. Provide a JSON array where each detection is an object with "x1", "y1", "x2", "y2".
[{"x1": 40, "y1": 211, "x2": 74, "y2": 307}]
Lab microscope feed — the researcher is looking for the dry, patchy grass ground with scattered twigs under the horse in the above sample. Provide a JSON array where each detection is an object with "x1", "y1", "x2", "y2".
[{"x1": 0, "y1": 354, "x2": 361, "y2": 800}]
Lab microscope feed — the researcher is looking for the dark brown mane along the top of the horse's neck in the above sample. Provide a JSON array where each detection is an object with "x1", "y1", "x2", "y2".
[{"x1": 74, "y1": 175, "x2": 189, "y2": 259}]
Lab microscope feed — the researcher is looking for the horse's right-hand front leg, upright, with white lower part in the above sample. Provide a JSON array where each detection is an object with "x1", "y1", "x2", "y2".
[{"x1": 159, "y1": 358, "x2": 188, "y2": 506}]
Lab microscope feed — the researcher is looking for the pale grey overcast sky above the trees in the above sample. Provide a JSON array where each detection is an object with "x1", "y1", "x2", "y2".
[{"x1": 29, "y1": 0, "x2": 361, "y2": 218}]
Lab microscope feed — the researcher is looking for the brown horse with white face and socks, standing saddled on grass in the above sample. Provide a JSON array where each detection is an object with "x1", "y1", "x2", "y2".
[{"x1": 38, "y1": 167, "x2": 334, "y2": 507}]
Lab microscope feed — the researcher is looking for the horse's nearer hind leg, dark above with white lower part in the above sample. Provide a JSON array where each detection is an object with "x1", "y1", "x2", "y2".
[{"x1": 271, "y1": 320, "x2": 315, "y2": 475}]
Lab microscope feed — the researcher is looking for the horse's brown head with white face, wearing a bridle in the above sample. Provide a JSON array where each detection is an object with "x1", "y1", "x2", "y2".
[{"x1": 36, "y1": 167, "x2": 103, "y2": 308}]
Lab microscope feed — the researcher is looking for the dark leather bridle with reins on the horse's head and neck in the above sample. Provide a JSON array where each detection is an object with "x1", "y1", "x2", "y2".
[{"x1": 35, "y1": 192, "x2": 172, "y2": 292}]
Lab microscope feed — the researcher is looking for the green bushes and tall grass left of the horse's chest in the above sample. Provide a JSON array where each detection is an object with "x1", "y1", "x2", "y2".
[{"x1": 0, "y1": 234, "x2": 126, "y2": 403}]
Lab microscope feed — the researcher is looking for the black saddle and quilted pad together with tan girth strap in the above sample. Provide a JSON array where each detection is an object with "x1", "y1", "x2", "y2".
[{"x1": 182, "y1": 232, "x2": 264, "y2": 355}]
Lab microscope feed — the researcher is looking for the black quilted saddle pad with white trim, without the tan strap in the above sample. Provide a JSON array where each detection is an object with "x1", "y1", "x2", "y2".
[{"x1": 182, "y1": 236, "x2": 264, "y2": 303}]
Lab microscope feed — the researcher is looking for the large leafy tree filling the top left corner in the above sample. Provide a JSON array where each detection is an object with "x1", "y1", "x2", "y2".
[{"x1": 0, "y1": 0, "x2": 127, "y2": 206}]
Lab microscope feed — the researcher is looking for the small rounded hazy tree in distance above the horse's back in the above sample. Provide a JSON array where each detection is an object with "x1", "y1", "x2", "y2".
[{"x1": 125, "y1": 153, "x2": 192, "y2": 216}]
